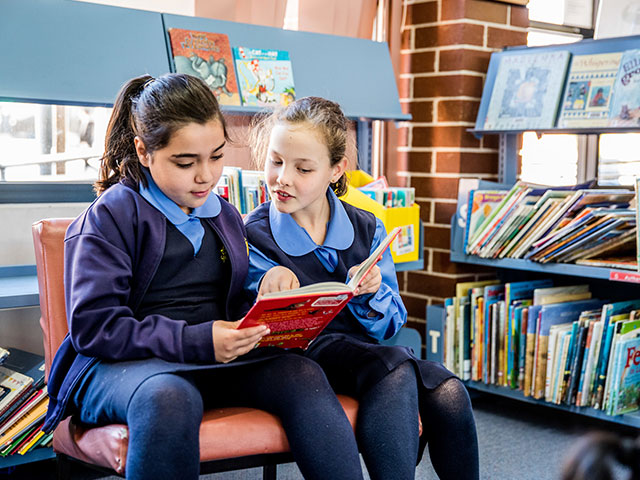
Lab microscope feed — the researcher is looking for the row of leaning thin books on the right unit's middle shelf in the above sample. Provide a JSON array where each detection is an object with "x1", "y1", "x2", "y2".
[{"x1": 464, "y1": 182, "x2": 637, "y2": 270}]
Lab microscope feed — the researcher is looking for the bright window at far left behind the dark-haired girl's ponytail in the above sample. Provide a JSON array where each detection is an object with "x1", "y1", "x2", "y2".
[{"x1": 0, "y1": 102, "x2": 111, "y2": 182}]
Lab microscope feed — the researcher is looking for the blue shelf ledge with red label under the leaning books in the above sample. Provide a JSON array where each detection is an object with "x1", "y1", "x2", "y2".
[{"x1": 451, "y1": 251, "x2": 640, "y2": 283}]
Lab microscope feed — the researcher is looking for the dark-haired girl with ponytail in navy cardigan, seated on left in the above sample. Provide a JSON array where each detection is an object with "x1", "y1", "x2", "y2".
[{"x1": 44, "y1": 74, "x2": 362, "y2": 480}]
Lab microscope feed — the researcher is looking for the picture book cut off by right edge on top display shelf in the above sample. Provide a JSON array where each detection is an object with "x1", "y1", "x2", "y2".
[{"x1": 609, "y1": 49, "x2": 640, "y2": 127}]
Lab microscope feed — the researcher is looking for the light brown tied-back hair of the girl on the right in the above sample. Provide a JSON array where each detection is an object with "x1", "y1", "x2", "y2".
[{"x1": 249, "y1": 97, "x2": 349, "y2": 196}]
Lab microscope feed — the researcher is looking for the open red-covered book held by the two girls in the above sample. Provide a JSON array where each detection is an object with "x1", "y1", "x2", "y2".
[{"x1": 238, "y1": 227, "x2": 400, "y2": 349}]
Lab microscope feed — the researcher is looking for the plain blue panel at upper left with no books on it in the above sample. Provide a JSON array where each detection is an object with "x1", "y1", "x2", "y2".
[{"x1": 0, "y1": 0, "x2": 170, "y2": 105}]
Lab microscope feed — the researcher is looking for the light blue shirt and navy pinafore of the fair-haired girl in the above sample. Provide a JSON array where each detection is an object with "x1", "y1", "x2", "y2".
[{"x1": 245, "y1": 189, "x2": 454, "y2": 462}]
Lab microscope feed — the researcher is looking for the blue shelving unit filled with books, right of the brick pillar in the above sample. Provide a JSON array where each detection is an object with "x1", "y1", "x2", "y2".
[{"x1": 444, "y1": 36, "x2": 640, "y2": 427}]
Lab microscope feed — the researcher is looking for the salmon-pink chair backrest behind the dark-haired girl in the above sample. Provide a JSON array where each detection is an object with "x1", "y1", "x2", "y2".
[{"x1": 31, "y1": 218, "x2": 73, "y2": 378}]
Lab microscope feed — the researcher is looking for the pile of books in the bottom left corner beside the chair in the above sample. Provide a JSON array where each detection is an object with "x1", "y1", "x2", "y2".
[{"x1": 0, "y1": 348, "x2": 53, "y2": 457}]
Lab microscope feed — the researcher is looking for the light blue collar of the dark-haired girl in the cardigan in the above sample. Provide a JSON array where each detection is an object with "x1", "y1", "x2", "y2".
[{"x1": 140, "y1": 169, "x2": 222, "y2": 256}]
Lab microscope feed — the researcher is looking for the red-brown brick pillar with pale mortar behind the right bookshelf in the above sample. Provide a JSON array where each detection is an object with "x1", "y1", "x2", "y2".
[{"x1": 390, "y1": 0, "x2": 529, "y2": 328}]
